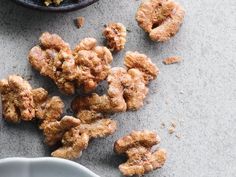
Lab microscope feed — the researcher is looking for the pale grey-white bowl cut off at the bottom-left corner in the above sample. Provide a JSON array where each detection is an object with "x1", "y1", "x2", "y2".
[{"x1": 0, "y1": 157, "x2": 99, "y2": 177}]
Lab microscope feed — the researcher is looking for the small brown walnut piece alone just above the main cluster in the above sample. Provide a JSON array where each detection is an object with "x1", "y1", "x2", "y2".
[{"x1": 103, "y1": 23, "x2": 127, "y2": 52}]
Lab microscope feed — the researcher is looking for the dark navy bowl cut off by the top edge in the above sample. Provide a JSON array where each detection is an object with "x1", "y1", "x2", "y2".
[{"x1": 13, "y1": 0, "x2": 98, "y2": 12}]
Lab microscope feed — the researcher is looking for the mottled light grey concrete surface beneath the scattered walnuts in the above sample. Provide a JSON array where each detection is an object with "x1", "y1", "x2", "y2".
[{"x1": 0, "y1": 0, "x2": 236, "y2": 177}]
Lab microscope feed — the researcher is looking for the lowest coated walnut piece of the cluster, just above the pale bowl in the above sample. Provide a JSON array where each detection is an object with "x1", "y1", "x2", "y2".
[{"x1": 52, "y1": 110, "x2": 116, "y2": 159}]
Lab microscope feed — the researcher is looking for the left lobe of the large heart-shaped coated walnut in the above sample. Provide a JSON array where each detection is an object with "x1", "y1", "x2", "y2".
[{"x1": 28, "y1": 32, "x2": 77, "y2": 94}]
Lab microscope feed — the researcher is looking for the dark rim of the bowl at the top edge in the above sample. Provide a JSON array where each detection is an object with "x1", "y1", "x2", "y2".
[{"x1": 13, "y1": 0, "x2": 99, "y2": 12}]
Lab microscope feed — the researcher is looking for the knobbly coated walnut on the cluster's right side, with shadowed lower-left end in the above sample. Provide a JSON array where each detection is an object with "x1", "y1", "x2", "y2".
[{"x1": 71, "y1": 52, "x2": 159, "y2": 113}]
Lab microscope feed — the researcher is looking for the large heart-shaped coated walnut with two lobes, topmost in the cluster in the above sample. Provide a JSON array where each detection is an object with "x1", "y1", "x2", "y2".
[{"x1": 28, "y1": 32, "x2": 113, "y2": 94}]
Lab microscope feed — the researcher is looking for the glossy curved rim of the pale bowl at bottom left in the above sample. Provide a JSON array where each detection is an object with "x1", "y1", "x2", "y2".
[{"x1": 0, "y1": 157, "x2": 100, "y2": 177}]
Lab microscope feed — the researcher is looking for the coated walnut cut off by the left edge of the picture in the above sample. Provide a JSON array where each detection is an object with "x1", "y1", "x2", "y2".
[{"x1": 0, "y1": 75, "x2": 35, "y2": 123}]
